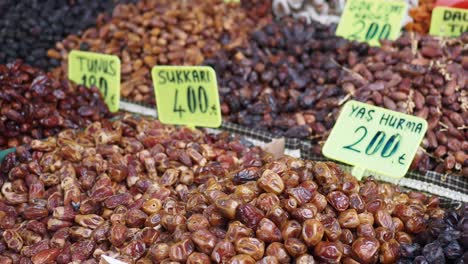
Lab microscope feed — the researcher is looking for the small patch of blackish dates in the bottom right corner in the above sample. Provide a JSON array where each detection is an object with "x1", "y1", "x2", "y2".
[{"x1": 398, "y1": 204, "x2": 468, "y2": 264}]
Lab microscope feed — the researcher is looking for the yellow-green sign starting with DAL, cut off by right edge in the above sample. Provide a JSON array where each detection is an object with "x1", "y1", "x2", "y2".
[{"x1": 429, "y1": 6, "x2": 468, "y2": 37}]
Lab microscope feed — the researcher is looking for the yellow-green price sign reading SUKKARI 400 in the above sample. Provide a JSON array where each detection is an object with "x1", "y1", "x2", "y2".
[{"x1": 151, "y1": 66, "x2": 222, "y2": 127}]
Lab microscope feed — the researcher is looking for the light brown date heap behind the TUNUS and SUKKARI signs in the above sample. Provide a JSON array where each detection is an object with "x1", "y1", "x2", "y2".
[{"x1": 48, "y1": 0, "x2": 268, "y2": 104}]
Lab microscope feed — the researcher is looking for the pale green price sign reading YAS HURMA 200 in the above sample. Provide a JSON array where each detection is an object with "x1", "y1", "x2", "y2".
[{"x1": 322, "y1": 101, "x2": 427, "y2": 178}]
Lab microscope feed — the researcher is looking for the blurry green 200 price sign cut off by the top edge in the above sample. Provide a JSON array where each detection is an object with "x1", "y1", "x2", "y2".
[{"x1": 336, "y1": 0, "x2": 407, "y2": 46}]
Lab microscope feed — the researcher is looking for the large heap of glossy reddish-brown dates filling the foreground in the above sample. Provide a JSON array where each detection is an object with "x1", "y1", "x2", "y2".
[{"x1": 0, "y1": 117, "x2": 444, "y2": 264}]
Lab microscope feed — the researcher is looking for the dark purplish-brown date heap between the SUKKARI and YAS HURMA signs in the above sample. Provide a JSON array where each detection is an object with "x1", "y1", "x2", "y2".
[{"x1": 205, "y1": 19, "x2": 368, "y2": 138}]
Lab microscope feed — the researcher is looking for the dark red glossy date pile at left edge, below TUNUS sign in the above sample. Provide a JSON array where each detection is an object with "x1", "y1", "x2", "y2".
[{"x1": 0, "y1": 61, "x2": 110, "y2": 150}]
